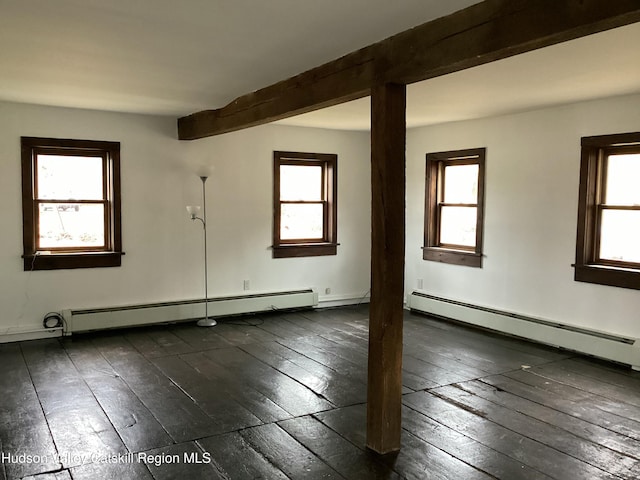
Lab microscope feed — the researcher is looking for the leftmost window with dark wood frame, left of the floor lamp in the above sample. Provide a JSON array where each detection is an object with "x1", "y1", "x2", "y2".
[{"x1": 21, "y1": 137, "x2": 122, "y2": 271}]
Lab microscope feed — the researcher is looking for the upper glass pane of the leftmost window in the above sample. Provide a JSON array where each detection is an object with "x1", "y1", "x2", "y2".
[{"x1": 37, "y1": 155, "x2": 103, "y2": 200}]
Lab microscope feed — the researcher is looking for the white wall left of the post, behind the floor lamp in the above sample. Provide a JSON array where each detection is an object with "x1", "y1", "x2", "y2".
[{"x1": 0, "y1": 103, "x2": 370, "y2": 336}]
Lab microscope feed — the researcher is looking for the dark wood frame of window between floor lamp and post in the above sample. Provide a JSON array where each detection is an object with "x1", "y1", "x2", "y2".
[{"x1": 272, "y1": 151, "x2": 338, "y2": 258}]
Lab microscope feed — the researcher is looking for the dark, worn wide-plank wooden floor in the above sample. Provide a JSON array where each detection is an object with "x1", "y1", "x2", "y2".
[{"x1": 0, "y1": 306, "x2": 640, "y2": 480}]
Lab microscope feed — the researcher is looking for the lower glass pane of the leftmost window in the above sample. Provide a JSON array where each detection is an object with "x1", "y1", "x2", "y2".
[{"x1": 38, "y1": 203, "x2": 105, "y2": 250}]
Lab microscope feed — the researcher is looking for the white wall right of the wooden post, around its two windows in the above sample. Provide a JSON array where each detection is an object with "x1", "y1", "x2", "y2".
[{"x1": 406, "y1": 95, "x2": 640, "y2": 337}]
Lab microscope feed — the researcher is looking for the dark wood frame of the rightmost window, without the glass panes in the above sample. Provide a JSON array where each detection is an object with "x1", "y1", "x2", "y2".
[{"x1": 574, "y1": 132, "x2": 640, "y2": 290}]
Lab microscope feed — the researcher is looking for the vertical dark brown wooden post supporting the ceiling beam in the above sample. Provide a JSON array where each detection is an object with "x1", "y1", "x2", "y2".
[{"x1": 367, "y1": 84, "x2": 406, "y2": 454}]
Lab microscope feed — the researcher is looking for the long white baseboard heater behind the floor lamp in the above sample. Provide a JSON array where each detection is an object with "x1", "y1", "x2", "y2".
[{"x1": 62, "y1": 289, "x2": 318, "y2": 335}]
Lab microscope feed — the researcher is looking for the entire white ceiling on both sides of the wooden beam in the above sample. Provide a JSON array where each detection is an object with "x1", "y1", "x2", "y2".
[{"x1": 0, "y1": 0, "x2": 640, "y2": 129}]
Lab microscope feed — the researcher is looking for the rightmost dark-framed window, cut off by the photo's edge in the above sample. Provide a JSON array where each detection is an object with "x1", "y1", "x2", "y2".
[{"x1": 575, "y1": 132, "x2": 640, "y2": 289}]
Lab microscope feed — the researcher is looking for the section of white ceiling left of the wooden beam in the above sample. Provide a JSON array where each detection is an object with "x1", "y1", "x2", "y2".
[{"x1": 0, "y1": 0, "x2": 478, "y2": 116}]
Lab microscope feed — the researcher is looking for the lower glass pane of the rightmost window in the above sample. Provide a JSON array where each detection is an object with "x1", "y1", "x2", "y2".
[{"x1": 600, "y1": 210, "x2": 640, "y2": 263}]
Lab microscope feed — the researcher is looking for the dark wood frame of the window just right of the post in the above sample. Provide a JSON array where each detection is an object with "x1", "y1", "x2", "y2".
[{"x1": 422, "y1": 148, "x2": 486, "y2": 268}]
